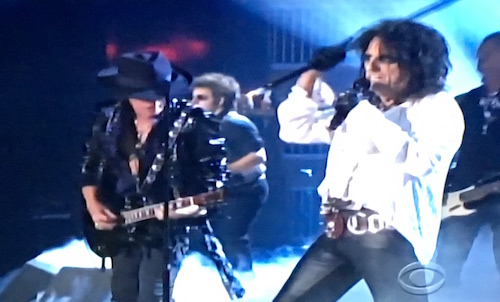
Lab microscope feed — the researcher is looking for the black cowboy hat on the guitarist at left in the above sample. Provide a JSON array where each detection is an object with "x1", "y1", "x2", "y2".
[{"x1": 97, "y1": 51, "x2": 192, "y2": 101}]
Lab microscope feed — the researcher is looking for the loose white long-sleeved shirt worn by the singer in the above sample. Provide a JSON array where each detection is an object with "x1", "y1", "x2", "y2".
[{"x1": 278, "y1": 83, "x2": 464, "y2": 265}]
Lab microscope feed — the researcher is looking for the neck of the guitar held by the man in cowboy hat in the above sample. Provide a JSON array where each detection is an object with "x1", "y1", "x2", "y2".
[{"x1": 121, "y1": 190, "x2": 224, "y2": 225}]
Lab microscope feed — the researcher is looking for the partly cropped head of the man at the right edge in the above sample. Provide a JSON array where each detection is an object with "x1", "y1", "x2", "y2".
[{"x1": 477, "y1": 41, "x2": 500, "y2": 92}]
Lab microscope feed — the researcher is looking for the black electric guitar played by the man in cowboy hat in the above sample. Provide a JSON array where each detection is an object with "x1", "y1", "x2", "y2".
[{"x1": 83, "y1": 189, "x2": 226, "y2": 258}]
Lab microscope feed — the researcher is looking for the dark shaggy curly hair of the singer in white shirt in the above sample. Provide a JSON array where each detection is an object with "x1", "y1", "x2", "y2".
[{"x1": 357, "y1": 19, "x2": 451, "y2": 98}]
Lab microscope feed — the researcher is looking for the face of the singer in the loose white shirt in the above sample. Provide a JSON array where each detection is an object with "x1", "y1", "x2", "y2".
[{"x1": 364, "y1": 37, "x2": 410, "y2": 105}]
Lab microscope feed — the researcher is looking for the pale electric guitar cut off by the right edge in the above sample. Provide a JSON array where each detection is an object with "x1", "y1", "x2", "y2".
[{"x1": 441, "y1": 180, "x2": 500, "y2": 220}]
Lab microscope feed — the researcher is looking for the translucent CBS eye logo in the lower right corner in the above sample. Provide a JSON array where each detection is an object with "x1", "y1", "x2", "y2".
[{"x1": 398, "y1": 262, "x2": 446, "y2": 295}]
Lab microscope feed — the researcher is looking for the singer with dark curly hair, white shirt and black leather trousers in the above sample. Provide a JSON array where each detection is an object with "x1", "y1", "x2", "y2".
[{"x1": 274, "y1": 20, "x2": 464, "y2": 302}]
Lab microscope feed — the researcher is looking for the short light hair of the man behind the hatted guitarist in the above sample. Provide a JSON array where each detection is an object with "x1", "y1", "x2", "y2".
[{"x1": 191, "y1": 72, "x2": 240, "y2": 112}]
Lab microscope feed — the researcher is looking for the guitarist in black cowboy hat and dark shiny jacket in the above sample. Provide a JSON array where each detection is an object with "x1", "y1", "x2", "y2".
[{"x1": 81, "y1": 52, "x2": 242, "y2": 302}]
